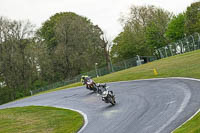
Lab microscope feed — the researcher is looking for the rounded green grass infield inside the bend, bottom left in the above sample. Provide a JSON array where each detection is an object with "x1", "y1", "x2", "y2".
[{"x1": 0, "y1": 106, "x2": 84, "y2": 133}]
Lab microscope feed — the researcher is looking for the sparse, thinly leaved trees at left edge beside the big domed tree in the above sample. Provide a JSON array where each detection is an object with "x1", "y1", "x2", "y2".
[{"x1": 0, "y1": 17, "x2": 37, "y2": 100}]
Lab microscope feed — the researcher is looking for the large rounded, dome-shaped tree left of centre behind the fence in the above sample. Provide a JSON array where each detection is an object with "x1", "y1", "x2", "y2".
[{"x1": 38, "y1": 12, "x2": 105, "y2": 81}]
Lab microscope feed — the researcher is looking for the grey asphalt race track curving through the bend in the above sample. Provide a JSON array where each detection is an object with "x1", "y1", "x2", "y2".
[{"x1": 0, "y1": 79, "x2": 200, "y2": 133}]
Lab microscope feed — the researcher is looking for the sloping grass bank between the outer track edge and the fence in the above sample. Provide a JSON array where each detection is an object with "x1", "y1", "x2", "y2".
[{"x1": 46, "y1": 50, "x2": 200, "y2": 93}]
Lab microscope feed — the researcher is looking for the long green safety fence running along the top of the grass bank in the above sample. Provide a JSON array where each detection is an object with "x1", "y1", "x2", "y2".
[{"x1": 31, "y1": 33, "x2": 200, "y2": 95}]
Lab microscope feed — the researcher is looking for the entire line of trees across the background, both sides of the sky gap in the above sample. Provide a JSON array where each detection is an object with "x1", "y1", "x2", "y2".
[{"x1": 0, "y1": 2, "x2": 200, "y2": 104}]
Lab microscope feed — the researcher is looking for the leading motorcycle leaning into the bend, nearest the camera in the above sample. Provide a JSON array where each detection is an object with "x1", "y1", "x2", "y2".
[{"x1": 102, "y1": 87, "x2": 116, "y2": 105}]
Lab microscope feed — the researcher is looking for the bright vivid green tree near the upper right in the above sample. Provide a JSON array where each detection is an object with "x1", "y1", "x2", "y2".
[{"x1": 165, "y1": 13, "x2": 186, "y2": 41}]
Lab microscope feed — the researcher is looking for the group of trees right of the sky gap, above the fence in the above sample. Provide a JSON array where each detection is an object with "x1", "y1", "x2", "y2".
[{"x1": 111, "y1": 2, "x2": 200, "y2": 62}]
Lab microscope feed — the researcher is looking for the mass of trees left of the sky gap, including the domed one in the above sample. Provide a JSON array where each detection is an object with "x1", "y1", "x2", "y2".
[{"x1": 0, "y1": 12, "x2": 108, "y2": 104}]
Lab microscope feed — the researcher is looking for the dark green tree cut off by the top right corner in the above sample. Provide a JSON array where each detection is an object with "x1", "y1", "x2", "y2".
[{"x1": 185, "y1": 2, "x2": 200, "y2": 35}]
